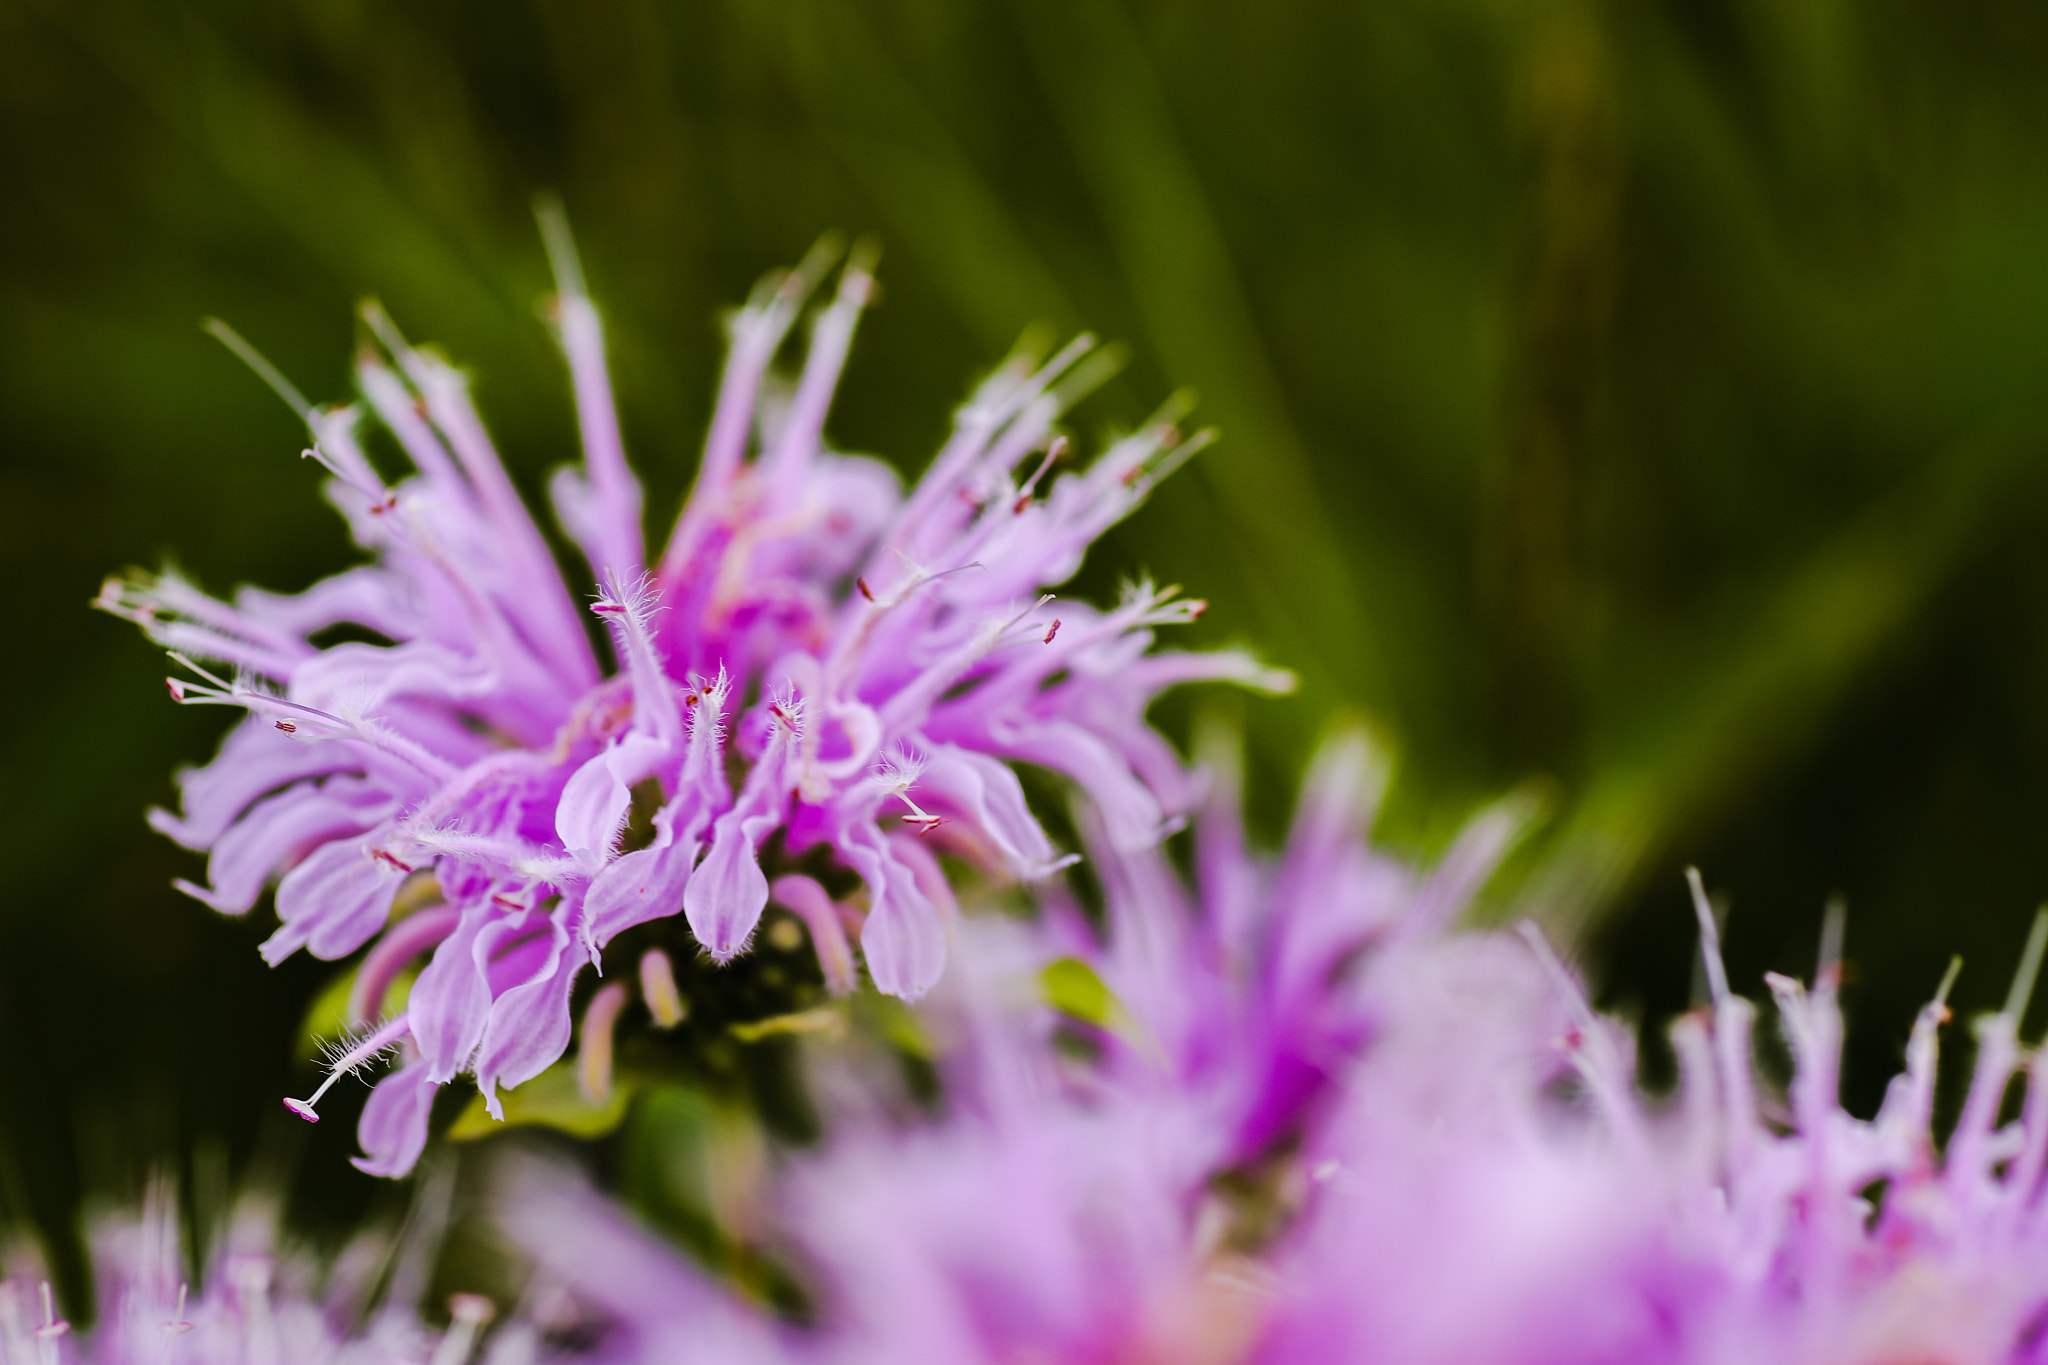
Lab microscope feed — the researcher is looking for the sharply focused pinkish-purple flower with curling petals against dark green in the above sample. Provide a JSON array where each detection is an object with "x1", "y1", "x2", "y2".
[{"x1": 98, "y1": 219, "x2": 1290, "y2": 1173}]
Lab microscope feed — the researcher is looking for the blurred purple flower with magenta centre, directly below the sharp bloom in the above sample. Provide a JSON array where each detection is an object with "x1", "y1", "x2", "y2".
[{"x1": 500, "y1": 741, "x2": 1526, "y2": 1365}]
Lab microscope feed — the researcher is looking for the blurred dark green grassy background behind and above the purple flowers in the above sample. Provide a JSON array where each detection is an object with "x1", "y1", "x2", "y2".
[{"x1": 12, "y1": 0, "x2": 2048, "y2": 1260}]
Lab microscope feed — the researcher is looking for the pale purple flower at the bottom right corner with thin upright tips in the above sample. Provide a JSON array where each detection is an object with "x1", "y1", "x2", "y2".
[{"x1": 1255, "y1": 896, "x2": 2048, "y2": 1365}]
